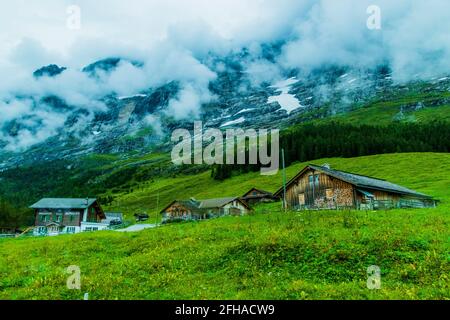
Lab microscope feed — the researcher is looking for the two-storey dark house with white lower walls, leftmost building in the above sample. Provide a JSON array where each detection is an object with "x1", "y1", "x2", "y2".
[{"x1": 30, "y1": 198, "x2": 109, "y2": 235}]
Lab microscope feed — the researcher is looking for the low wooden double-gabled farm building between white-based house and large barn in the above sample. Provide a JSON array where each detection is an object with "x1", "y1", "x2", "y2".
[{"x1": 161, "y1": 197, "x2": 250, "y2": 222}]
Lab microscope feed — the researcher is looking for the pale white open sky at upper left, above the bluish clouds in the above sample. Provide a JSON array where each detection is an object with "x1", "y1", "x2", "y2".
[{"x1": 0, "y1": 0, "x2": 302, "y2": 68}]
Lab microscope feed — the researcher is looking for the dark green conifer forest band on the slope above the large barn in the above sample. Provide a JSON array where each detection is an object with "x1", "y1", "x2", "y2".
[{"x1": 211, "y1": 121, "x2": 450, "y2": 180}]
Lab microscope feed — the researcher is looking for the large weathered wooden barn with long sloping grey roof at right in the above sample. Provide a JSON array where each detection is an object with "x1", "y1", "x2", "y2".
[{"x1": 274, "y1": 165, "x2": 436, "y2": 210}]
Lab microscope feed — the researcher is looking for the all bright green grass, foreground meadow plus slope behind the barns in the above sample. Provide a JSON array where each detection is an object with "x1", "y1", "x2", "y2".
[{"x1": 0, "y1": 153, "x2": 450, "y2": 299}]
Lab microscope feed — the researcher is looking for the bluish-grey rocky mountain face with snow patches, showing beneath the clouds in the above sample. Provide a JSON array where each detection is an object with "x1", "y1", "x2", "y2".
[{"x1": 0, "y1": 49, "x2": 450, "y2": 169}]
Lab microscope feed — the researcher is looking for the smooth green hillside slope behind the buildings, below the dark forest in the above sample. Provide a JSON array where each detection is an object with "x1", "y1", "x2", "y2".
[{"x1": 108, "y1": 153, "x2": 450, "y2": 219}]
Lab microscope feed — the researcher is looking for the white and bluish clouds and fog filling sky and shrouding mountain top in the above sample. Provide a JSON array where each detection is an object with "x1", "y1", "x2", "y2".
[{"x1": 0, "y1": 0, "x2": 450, "y2": 152}]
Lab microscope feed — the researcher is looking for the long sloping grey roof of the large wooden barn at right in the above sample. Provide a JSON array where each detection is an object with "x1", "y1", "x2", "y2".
[{"x1": 275, "y1": 164, "x2": 432, "y2": 198}]
